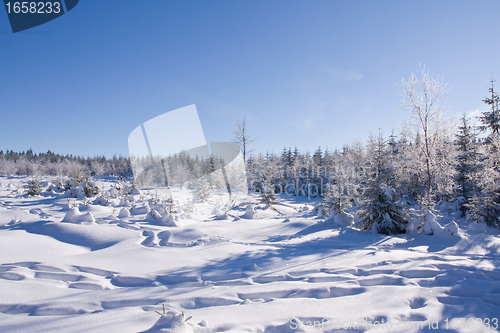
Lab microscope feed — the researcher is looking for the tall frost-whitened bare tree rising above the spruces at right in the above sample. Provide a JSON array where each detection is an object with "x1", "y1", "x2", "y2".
[{"x1": 400, "y1": 66, "x2": 447, "y2": 208}]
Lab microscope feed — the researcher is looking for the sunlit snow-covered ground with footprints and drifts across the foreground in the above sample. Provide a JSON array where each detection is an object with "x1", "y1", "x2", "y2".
[{"x1": 0, "y1": 177, "x2": 500, "y2": 332}]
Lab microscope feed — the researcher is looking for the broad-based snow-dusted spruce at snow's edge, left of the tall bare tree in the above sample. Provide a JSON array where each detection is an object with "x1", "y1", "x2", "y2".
[{"x1": 358, "y1": 134, "x2": 408, "y2": 235}]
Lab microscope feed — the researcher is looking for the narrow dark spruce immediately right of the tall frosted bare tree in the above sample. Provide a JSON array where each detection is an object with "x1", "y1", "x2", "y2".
[{"x1": 455, "y1": 114, "x2": 482, "y2": 216}]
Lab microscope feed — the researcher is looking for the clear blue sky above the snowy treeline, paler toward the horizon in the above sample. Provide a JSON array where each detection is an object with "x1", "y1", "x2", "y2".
[{"x1": 0, "y1": 0, "x2": 500, "y2": 157}]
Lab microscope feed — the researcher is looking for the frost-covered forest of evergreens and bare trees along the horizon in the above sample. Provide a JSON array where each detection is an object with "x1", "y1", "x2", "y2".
[{"x1": 0, "y1": 67, "x2": 500, "y2": 234}]
